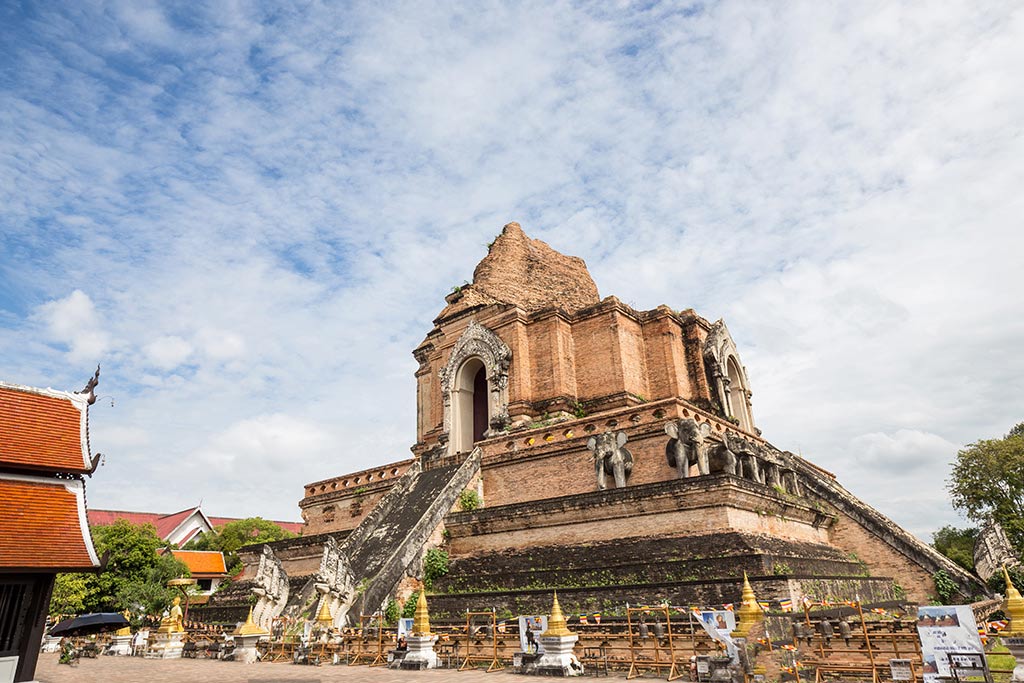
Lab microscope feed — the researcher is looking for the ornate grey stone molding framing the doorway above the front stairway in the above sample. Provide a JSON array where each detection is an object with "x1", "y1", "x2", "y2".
[{"x1": 439, "y1": 321, "x2": 512, "y2": 455}]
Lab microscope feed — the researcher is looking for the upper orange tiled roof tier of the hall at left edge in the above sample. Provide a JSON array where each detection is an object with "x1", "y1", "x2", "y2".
[{"x1": 0, "y1": 383, "x2": 91, "y2": 472}]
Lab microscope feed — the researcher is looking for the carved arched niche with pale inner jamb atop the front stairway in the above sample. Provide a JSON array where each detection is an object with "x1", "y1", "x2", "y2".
[{"x1": 440, "y1": 321, "x2": 512, "y2": 455}]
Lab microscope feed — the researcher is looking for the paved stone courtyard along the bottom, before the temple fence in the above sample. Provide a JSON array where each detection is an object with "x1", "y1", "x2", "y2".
[{"x1": 36, "y1": 653, "x2": 622, "y2": 683}]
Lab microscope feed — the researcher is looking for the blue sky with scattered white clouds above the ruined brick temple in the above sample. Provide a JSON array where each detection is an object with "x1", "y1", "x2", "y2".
[{"x1": 0, "y1": 1, "x2": 1024, "y2": 538}]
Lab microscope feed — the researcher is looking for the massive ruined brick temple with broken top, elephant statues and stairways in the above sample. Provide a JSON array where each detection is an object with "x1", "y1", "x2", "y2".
[{"x1": 205, "y1": 223, "x2": 986, "y2": 625}]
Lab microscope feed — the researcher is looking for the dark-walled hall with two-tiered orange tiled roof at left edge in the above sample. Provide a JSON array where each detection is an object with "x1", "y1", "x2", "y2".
[{"x1": 0, "y1": 369, "x2": 101, "y2": 681}]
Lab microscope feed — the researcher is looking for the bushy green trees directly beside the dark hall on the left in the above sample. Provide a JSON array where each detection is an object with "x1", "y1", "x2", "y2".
[{"x1": 50, "y1": 519, "x2": 189, "y2": 614}]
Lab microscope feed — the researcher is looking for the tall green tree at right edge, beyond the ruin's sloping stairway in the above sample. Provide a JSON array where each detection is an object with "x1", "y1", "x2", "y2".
[{"x1": 946, "y1": 423, "x2": 1024, "y2": 549}]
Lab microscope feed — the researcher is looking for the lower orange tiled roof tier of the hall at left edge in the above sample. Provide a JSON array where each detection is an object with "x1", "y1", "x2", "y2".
[{"x1": 0, "y1": 473, "x2": 99, "y2": 571}]
